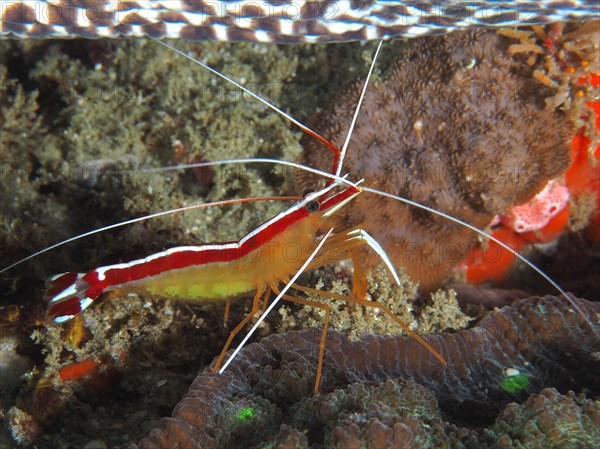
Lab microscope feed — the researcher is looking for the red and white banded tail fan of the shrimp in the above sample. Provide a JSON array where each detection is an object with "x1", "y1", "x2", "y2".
[{"x1": 44, "y1": 272, "x2": 104, "y2": 323}]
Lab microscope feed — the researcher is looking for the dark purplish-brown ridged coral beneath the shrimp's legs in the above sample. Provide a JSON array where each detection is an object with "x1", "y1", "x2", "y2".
[{"x1": 132, "y1": 296, "x2": 600, "y2": 449}]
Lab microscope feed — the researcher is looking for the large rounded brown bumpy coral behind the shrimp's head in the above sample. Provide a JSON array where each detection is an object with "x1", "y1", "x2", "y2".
[{"x1": 299, "y1": 31, "x2": 571, "y2": 289}]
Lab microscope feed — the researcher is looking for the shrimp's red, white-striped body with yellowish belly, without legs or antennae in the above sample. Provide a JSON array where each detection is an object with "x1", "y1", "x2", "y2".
[{"x1": 45, "y1": 183, "x2": 361, "y2": 322}]
